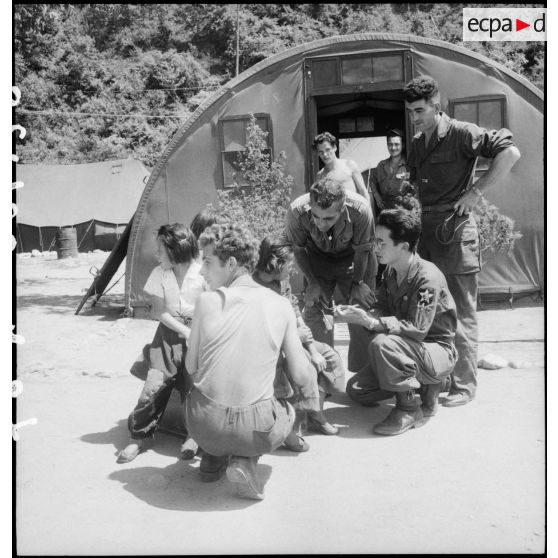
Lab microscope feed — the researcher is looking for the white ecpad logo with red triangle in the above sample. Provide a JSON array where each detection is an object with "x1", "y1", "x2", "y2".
[{"x1": 463, "y1": 8, "x2": 546, "y2": 41}]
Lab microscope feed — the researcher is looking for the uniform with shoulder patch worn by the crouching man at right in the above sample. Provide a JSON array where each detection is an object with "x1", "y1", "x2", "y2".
[{"x1": 347, "y1": 254, "x2": 457, "y2": 405}]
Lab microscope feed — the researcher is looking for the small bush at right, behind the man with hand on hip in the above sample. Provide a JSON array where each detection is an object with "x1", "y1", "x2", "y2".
[{"x1": 473, "y1": 194, "x2": 522, "y2": 259}]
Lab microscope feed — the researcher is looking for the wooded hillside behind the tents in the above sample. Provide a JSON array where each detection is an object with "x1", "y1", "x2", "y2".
[{"x1": 14, "y1": 4, "x2": 545, "y2": 166}]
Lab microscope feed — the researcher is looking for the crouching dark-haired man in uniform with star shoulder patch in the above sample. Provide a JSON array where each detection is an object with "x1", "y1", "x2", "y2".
[{"x1": 336, "y1": 209, "x2": 457, "y2": 436}]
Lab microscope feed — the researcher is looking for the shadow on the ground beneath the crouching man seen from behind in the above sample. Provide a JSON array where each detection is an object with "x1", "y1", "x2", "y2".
[{"x1": 108, "y1": 459, "x2": 272, "y2": 512}]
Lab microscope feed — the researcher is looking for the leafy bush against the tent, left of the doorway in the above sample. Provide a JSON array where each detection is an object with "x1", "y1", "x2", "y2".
[{"x1": 213, "y1": 114, "x2": 293, "y2": 240}]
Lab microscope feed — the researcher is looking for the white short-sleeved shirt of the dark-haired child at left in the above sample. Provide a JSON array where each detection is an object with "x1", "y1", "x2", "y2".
[{"x1": 143, "y1": 261, "x2": 205, "y2": 320}]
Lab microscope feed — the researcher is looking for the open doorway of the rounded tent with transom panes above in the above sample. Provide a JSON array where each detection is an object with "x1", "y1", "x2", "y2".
[{"x1": 304, "y1": 50, "x2": 412, "y2": 185}]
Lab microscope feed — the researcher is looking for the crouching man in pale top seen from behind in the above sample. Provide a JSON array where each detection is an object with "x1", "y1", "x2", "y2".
[{"x1": 186, "y1": 224, "x2": 316, "y2": 500}]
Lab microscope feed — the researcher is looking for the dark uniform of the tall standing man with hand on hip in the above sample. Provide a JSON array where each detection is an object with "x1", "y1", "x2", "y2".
[{"x1": 407, "y1": 113, "x2": 514, "y2": 399}]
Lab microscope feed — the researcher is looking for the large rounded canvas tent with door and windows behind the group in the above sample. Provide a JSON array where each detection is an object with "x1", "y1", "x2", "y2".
[{"x1": 85, "y1": 33, "x2": 544, "y2": 315}]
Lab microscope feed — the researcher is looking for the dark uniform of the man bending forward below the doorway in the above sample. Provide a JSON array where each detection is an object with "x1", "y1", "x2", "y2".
[{"x1": 286, "y1": 192, "x2": 376, "y2": 370}]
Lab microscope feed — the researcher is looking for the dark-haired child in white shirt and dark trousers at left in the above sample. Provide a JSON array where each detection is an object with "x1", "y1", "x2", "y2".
[{"x1": 117, "y1": 223, "x2": 205, "y2": 463}]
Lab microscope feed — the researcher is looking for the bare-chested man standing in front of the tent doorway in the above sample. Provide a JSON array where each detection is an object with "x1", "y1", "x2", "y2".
[{"x1": 312, "y1": 132, "x2": 370, "y2": 202}]
